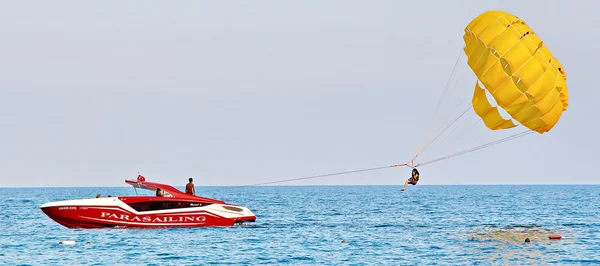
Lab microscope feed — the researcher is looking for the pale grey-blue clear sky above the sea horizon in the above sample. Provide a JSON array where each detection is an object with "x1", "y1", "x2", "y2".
[{"x1": 0, "y1": 0, "x2": 600, "y2": 187}]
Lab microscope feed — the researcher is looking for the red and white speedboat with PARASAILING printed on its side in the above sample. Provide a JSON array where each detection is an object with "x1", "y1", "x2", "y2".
[{"x1": 40, "y1": 175, "x2": 256, "y2": 228}]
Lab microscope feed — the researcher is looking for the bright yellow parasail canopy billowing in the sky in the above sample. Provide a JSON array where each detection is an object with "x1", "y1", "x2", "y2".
[{"x1": 463, "y1": 10, "x2": 569, "y2": 134}]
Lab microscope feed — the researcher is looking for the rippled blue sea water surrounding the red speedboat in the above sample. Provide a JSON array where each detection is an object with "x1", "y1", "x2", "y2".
[{"x1": 0, "y1": 185, "x2": 600, "y2": 265}]
